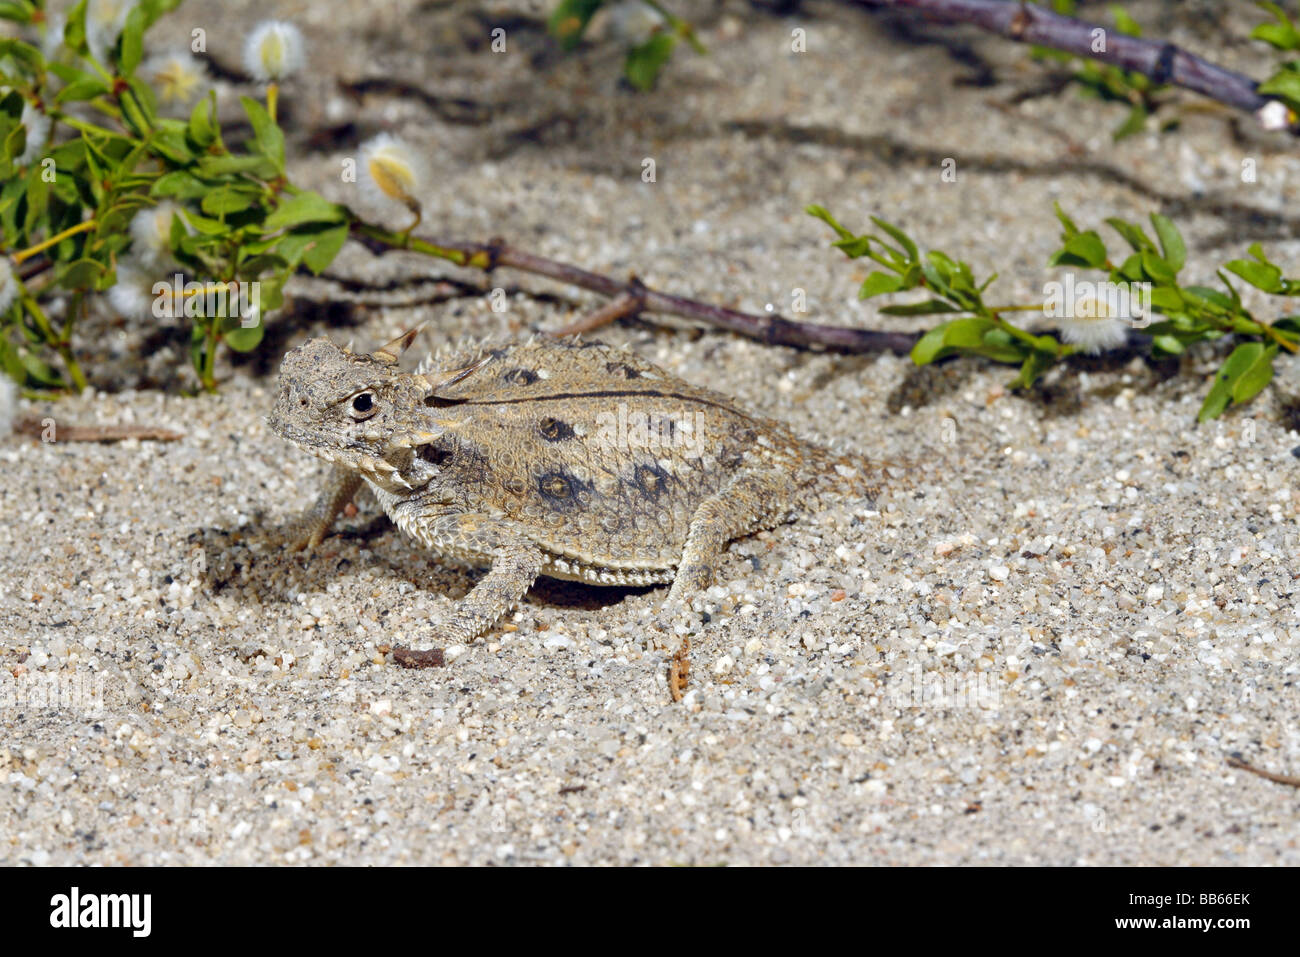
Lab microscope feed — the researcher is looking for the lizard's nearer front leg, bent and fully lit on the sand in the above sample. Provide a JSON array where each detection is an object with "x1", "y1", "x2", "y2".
[{"x1": 399, "y1": 512, "x2": 546, "y2": 644}]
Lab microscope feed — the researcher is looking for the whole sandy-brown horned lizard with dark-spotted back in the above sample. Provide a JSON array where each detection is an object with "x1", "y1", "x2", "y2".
[{"x1": 269, "y1": 330, "x2": 880, "y2": 657}]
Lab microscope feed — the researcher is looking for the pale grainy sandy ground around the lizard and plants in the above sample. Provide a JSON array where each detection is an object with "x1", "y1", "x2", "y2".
[{"x1": 0, "y1": 1, "x2": 1300, "y2": 865}]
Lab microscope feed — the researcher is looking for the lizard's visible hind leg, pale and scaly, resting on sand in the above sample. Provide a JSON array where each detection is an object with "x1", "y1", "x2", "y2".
[{"x1": 664, "y1": 471, "x2": 794, "y2": 606}]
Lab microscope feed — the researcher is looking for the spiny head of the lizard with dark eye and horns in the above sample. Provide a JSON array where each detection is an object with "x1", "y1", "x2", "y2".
[{"x1": 268, "y1": 329, "x2": 449, "y2": 489}]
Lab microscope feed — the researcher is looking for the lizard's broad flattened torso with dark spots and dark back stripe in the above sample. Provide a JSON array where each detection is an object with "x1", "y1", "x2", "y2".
[{"x1": 416, "y1": 341, "x2": 800, "y2": 583}]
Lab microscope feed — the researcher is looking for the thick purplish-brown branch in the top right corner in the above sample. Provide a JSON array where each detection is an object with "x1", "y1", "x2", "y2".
[{"x1": 855, "y1": 0, "x2": 1297, "y2": 133}]
